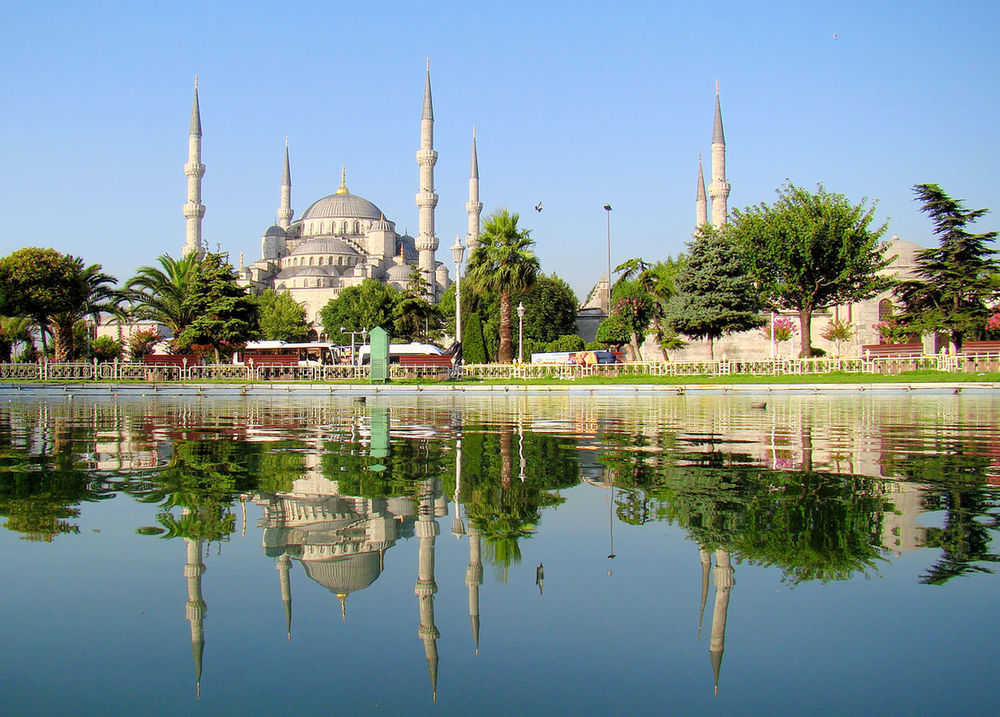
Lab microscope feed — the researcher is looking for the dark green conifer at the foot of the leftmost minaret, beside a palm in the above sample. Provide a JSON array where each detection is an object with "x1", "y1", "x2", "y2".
[{"x1": 177, "y1": 253, "x2": 260, "y2": 362}]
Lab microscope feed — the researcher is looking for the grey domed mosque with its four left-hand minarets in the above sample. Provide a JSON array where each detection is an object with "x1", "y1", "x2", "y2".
[{"x1": 182, "y1": 61, "x2": 483, "y2": 332}]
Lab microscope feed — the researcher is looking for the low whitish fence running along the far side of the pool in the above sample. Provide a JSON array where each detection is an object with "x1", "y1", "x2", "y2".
[{"x1": 0, "y1": 353, "x2": 1000, "y2": 383}]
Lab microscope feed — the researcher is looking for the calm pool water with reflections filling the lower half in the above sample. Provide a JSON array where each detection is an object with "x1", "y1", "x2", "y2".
[{"x1": 0, "y1": 392, "x2": 1000, "y2": 715}]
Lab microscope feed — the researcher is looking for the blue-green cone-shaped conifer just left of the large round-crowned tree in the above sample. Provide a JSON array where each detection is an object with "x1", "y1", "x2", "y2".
[{"x1": 666, "y1": 225, "x2": 764, "y2": 359}]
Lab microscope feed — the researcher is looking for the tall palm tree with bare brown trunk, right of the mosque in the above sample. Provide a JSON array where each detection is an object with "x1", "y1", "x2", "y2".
[{"x1": 468, "y1": 209, "x2": 539, "y2": 363}]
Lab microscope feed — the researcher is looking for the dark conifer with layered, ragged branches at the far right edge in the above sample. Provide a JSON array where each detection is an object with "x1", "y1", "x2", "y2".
[{"x1": 897, "y1": 184, "x2": 1000, "y2": 350}]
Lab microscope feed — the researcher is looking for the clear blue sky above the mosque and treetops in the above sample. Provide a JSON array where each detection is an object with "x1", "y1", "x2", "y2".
[{"x1": 0, "y1": 0, "x2": 1000, "y2": 299}]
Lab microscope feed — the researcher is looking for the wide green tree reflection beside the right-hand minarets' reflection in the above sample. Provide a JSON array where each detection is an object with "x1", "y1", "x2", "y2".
[{"x1": 603, "y1": 436, "x2": 891, "y2": 584}]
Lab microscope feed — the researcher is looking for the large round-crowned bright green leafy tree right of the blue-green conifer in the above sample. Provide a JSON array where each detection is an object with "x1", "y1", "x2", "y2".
[{"x1": 727, "y1": 182, "x2": 893, "y2": 358}]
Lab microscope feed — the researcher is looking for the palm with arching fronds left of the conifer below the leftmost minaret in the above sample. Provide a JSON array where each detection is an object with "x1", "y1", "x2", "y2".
[{"x1": 125, "y1": 253, "x2": 201, "y2": 338}]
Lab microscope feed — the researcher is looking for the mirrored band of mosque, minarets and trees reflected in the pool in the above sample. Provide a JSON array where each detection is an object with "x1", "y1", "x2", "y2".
[{"x1": 0, "y1": 398, "x2": 1000, "y2": 700}]
